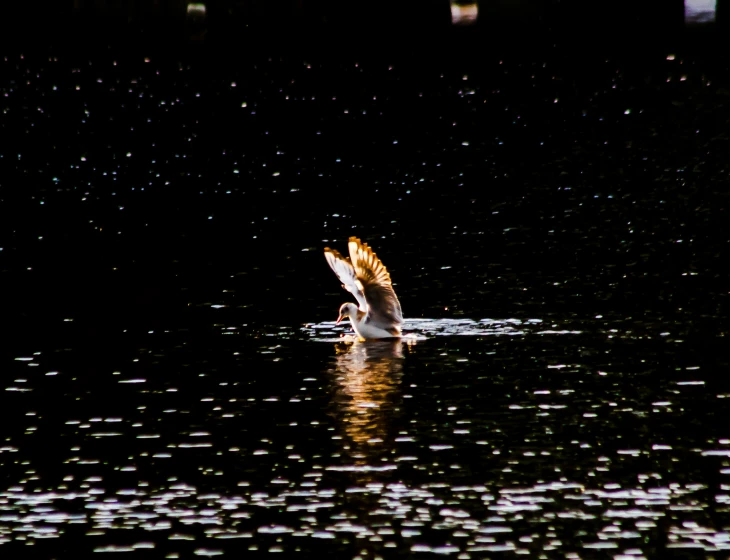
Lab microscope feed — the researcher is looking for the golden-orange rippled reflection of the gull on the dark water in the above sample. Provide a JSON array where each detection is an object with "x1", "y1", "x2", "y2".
[{"x1": 332, "y1": 340, "x2": 407, "y2": 467}]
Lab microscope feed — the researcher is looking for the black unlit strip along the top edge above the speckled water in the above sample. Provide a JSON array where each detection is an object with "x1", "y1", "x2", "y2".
[{"x1": 0, "y1": 0, "x2": 716, "y2": 50}]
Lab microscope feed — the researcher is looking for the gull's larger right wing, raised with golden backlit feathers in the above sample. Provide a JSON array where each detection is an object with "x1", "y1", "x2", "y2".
[{"x1": 347, "y1": 237, "x2": 403, "y2": 329}]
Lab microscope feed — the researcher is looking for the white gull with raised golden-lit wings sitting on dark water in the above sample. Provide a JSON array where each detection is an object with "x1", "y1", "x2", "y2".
[{"x1": 324, "y1": 237, "x2": 403, "y2": 340}]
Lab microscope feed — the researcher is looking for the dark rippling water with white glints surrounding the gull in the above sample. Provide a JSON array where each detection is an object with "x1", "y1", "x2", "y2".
[{"x1": 0, "y1": 38, "x2": 730, "y2": 559}]
